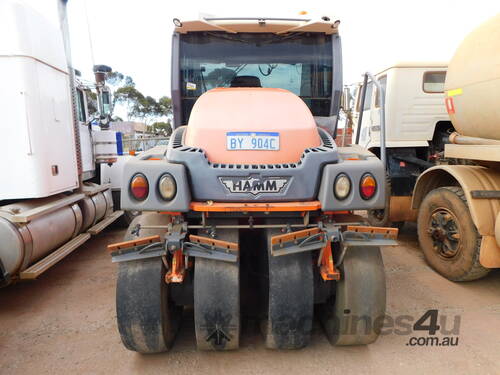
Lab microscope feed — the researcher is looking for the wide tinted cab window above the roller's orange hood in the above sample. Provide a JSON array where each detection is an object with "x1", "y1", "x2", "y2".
[{"x1": 180, "y1": 32, "x2": 333, "y2": 123}]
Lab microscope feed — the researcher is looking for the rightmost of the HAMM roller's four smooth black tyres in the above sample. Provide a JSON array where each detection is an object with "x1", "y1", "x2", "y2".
[{"x1": 320, "y1": 246, "x2": 386, "y2": 346}]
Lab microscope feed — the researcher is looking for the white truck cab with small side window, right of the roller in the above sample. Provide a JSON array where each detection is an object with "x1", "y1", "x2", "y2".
[{"x1": 354, "y1": 62, "x2": 450, "y2": 149}]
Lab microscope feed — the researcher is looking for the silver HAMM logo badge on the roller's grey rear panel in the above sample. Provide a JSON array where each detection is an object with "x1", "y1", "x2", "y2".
[{"x1": 219, "y1": 175, "x2": 290, "y2": 195}]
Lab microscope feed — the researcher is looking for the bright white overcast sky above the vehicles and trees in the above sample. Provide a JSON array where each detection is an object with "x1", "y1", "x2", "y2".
[{"x1": 19, "y1": 0, "x2": 500, "y2": 98}]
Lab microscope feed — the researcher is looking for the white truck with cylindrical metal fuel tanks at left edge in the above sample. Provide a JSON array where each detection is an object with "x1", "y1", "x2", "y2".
[{"x1": 0, "y1": 1, "x2": 122, "y2": 285}]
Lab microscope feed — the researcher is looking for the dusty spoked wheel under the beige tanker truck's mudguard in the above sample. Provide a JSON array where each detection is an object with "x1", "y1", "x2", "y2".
[{"x1": 417, "y1": 186, "x2": 489, "y2": 281}]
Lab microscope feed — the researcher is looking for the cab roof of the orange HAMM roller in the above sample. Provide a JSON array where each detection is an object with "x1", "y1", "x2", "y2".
[{"x1": 174, "y1": 16, "x2": 340, "y2": 34}]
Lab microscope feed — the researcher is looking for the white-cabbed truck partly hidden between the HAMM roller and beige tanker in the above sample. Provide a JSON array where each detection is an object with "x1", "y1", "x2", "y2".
[{"x1": 351, "y1": 62, "x2": 454, "y2": 226}]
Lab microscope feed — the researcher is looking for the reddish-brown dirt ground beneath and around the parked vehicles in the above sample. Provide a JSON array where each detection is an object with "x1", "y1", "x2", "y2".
[{"x1": 0, "y1": 225, "x2": 500, "y2": 375}]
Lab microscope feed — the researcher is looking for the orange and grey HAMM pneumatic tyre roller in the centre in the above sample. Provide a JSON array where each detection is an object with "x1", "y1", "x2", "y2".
[{"x1": 109, "y1": 17, "x2": 397, "y2": 353}]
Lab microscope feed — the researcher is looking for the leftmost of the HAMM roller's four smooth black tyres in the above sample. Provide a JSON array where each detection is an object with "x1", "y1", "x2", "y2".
[{"x1": 116, "y1": 213, "x2": 182, "y2": 354}]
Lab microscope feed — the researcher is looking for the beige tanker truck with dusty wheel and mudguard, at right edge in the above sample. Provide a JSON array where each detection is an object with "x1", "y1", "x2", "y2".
[{"x1": 412, "y1": 15, "x2": 500, "y2": 281}]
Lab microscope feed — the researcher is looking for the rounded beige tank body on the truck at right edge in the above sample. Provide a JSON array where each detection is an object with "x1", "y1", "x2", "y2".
[{"x1": 445, "y1": 14, "x2": 500, "y2": 140}]
